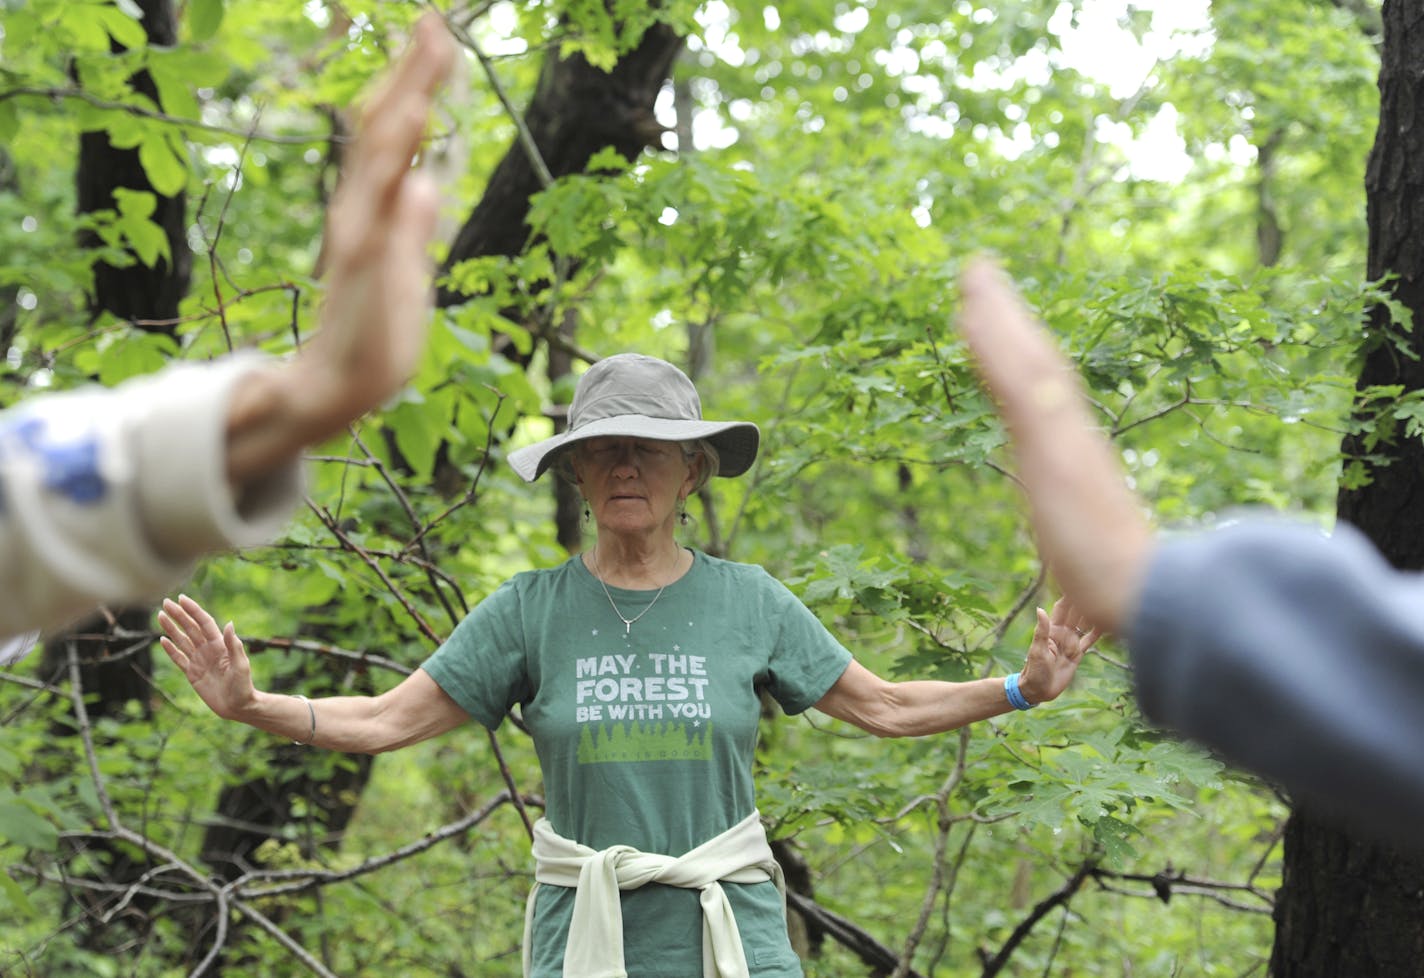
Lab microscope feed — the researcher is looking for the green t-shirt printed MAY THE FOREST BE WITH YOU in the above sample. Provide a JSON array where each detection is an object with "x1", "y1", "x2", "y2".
[{"x1": 423, "y1": 551, "x2": 850, "y2": 978}]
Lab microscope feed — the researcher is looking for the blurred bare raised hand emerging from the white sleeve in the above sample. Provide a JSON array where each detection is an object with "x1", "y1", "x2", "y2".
[{"x1": 228, "y1": 13, "x2": 454, "y2": 484}]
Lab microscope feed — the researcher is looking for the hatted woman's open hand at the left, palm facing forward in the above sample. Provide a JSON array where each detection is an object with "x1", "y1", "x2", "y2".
[{"x1": 158, "y1": 595, "x2": 256, "y2": 720}]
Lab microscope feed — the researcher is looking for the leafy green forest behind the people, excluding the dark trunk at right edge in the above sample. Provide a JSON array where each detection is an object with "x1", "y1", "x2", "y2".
[{"x1": 0, "y1": 0, "x2": 1401, "y2": 978}]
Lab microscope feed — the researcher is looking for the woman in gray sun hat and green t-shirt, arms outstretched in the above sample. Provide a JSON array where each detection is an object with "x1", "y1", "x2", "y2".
[{"x1": 159, "y1": 354, "x2": 1098, "y2": 978}]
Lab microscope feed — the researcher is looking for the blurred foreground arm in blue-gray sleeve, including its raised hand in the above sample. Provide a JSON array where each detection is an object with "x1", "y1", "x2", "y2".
[{"x1": 960, "y1": 261, "x2": 1424, "y2": 848}]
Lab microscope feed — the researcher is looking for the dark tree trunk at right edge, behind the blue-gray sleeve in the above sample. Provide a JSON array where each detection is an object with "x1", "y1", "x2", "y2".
[{"x1": 1272, "y1": 0, "x2": 1424, "y2": 978}]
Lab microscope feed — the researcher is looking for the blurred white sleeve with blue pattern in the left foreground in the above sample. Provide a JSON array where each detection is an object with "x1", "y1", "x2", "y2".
[{"x1": 0, "y1": 354, "x2": 300, "y2": 643}]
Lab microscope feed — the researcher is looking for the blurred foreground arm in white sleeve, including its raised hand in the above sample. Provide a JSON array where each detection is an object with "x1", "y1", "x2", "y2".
[{"x1": 0, "y1": 14, "x2": 454, "y2": 646}]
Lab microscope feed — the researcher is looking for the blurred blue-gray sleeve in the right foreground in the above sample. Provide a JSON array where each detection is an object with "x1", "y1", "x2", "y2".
[{"x1": 1126, "y1": 521, "x2": 1424, "y2": 844}]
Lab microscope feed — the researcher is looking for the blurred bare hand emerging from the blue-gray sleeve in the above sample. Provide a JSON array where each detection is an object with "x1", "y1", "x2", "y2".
[{"x1": 960, "y1": 259, "x2": 1153, "y2": 632}]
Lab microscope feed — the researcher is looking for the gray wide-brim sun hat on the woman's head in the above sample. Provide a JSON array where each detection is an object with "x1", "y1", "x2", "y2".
[{"x1": 508, "y1": 353, "x2": 762, "y2": 483}]
